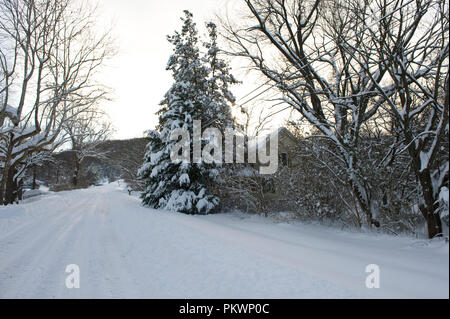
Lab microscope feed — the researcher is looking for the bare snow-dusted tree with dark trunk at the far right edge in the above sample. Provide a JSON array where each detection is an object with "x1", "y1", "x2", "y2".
[{"x1": 359, "y1": 0, "x2": 449, "y2": 238}]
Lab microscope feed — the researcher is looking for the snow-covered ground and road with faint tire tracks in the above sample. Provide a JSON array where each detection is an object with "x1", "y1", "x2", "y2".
[{"x1": 0, "y1": 183, "x2": 449, "y2": 298}]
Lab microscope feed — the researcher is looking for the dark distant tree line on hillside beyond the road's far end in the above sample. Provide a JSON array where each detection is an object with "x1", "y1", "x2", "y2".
[{"x1": 23, "y1": 138, "x2": 148, "y2": 191}]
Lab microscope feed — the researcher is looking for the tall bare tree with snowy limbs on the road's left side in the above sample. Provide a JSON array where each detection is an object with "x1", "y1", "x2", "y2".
[{"x1": 0, "y1": 0, "x2": 113, "y2": 203}]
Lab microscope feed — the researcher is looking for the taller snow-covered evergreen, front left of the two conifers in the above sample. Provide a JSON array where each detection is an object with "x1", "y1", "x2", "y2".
[{"x1": 139, "y1": 11, "x2": 219, "y2": 214}]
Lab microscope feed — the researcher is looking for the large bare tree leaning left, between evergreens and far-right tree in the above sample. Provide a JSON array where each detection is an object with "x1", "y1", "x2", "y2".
[{"x1": 221, "y1": 0, "x2": 393, "y2": 225}]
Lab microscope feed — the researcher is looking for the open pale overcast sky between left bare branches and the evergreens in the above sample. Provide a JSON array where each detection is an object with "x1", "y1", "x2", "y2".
[{"x1": 91, "y1": 0, "x2": 292, "y2": 139}]
